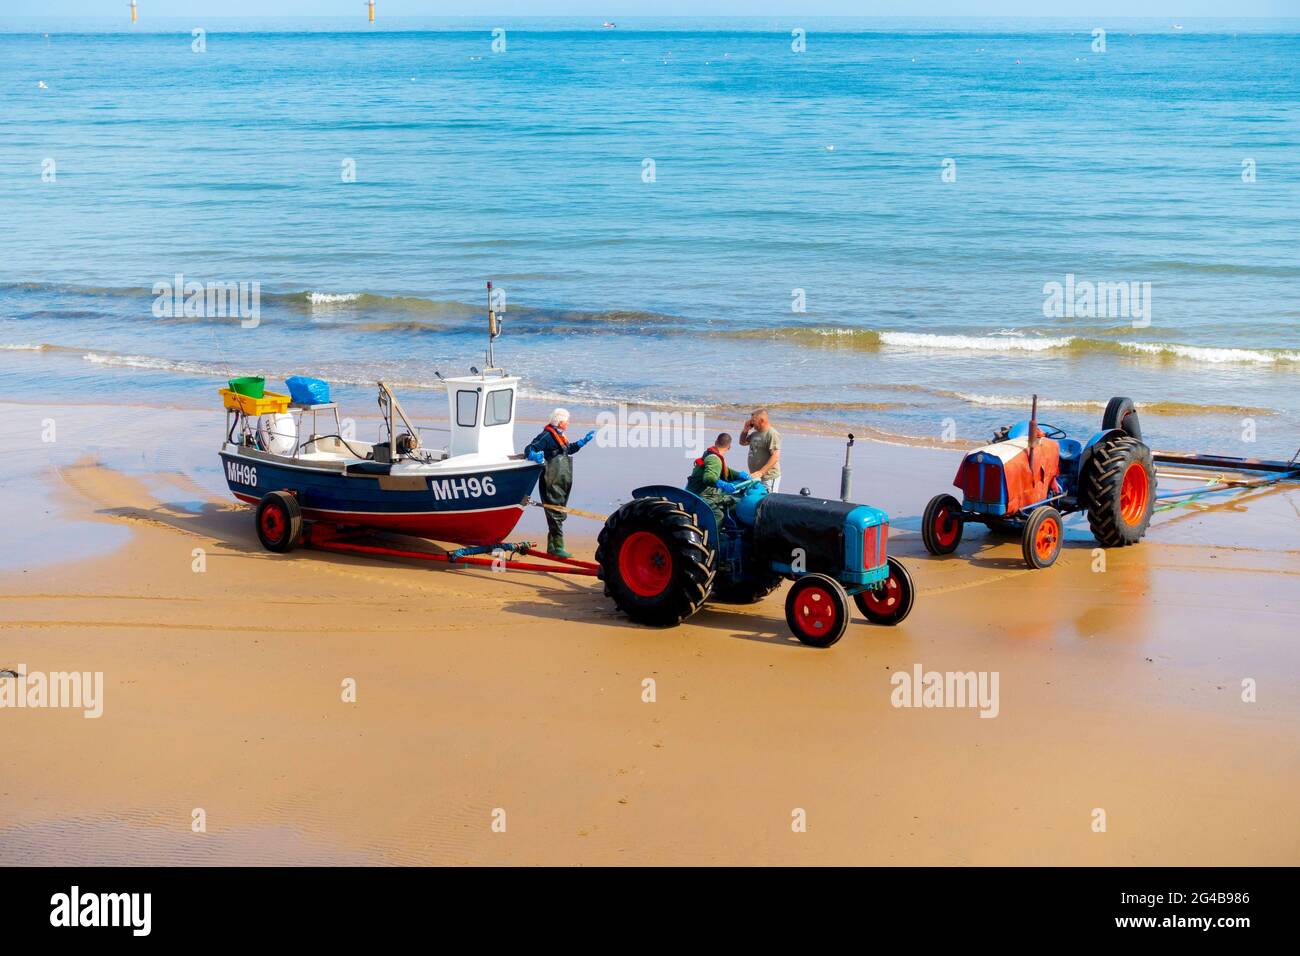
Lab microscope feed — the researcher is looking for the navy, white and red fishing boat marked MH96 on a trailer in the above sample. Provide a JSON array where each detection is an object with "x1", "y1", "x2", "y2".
[{"x1": 221, "y1": 284, "x2": 542, "y2": 551}]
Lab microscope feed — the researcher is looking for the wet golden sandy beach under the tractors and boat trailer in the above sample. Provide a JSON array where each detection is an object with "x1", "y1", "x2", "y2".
[{"x1": 0, "y1": 395, "x2": 1300, "y2": 865}]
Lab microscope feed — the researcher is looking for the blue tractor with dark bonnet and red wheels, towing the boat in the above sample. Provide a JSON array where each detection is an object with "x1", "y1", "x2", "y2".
[{"x1": 595, "y1": 480, "x2": 915, "y2": 648}]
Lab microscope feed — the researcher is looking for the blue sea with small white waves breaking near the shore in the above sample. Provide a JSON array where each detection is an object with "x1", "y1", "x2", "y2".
[{"x1": 0, "y1": 16, "x2": 1300, "y2": 458}]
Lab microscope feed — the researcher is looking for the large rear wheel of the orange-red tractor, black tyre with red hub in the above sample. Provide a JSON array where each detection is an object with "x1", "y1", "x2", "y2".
[{"x1": 1083, "y1": 434, "x2": 1156, "y2": 548}]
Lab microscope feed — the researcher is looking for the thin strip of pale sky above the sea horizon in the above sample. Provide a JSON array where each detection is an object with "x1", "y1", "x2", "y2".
[{"x1": 10, "y1": 0, "x2": 1300, "y2": 20}]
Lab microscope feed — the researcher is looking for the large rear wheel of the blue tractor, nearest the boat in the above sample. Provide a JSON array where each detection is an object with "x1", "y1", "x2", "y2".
[{"x1": 595, "y1": 498, "x2": 714, "y2": 627}]
